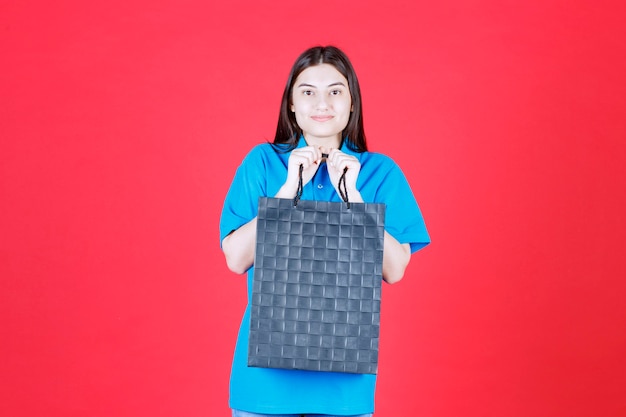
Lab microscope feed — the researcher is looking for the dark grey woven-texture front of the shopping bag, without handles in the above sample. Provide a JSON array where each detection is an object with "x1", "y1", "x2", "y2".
[{"x1": 248, "y1": 197, "x2": 385, "y2": 374}]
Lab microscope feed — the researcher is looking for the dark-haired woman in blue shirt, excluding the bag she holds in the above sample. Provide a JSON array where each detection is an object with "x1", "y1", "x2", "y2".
[{"x1": 220, "y1": 46, "x2": 430, "y2": 417}]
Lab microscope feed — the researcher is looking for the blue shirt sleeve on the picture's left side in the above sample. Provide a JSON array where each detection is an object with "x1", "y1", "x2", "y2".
[{"x1": 220, "y1": 146, "x2": 266, "y2": 245}]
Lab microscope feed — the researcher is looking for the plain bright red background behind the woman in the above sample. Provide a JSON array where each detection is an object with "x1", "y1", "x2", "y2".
[{"x1": 0, "y1": 0, "x2": 626, "y2": 417}]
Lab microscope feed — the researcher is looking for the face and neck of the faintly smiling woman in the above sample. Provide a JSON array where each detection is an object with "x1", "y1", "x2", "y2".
[{"x1": 291, "y1": 64, "x2": 352, "y2": 148}]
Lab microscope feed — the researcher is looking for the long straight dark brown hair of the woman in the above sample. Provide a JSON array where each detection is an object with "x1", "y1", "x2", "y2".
[{"x1": 274, "y1": 46, "x2": 367, "y2": 152}]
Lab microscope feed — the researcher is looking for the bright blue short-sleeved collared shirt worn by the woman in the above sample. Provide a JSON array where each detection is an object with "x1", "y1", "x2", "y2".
[{"x1": 220, "y1": 138, "x2": 430, "y2": 415}]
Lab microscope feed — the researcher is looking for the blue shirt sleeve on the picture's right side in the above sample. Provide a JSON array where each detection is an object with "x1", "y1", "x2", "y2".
[{"x1": 376, "y1": 159, "x2": 430, "y2": 253}]
